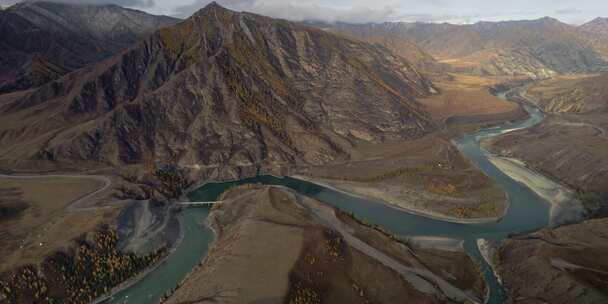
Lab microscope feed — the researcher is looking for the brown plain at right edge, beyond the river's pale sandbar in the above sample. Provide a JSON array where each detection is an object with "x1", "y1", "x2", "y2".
[{"x1": 484, "y1": 76, "x2": 608, "y2": 216}]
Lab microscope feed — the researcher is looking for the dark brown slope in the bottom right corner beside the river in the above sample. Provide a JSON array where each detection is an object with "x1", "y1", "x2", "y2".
[{"x1": 498, "y1": 219, "x2": 608, "y2": 304}]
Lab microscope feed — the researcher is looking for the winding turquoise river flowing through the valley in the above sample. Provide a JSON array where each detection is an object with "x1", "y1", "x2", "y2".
[{"x1": 106, "y1": 89, "x2": 550, "y2": 304}]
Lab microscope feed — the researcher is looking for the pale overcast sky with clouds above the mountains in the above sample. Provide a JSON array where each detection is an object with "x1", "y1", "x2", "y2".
[{"x1": 0, "y1": 0, "x2": 608, "y2": 24}]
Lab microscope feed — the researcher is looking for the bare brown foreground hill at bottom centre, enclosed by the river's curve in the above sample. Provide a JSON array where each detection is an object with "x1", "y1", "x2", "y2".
[{"x1": 168, "y1": 186, "x2": 485, "y2": 303}]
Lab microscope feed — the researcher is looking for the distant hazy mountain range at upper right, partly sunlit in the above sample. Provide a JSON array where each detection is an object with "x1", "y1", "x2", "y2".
[{"x1": 332, "y1": 18, "x2": 608, "y2": 77}]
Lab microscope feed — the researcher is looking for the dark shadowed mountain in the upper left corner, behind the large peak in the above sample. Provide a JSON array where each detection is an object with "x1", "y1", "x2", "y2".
[{"x1": 0, "y1": 2, "x2": 178, "y2": 93}]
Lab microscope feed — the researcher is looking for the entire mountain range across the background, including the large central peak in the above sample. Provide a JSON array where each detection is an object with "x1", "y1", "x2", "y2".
[{"x1": 0, "y1": 2, "x2": 606, "y2": 168}]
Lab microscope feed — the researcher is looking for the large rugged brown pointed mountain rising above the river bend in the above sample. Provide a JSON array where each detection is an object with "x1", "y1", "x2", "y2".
[{"x1": 0, "y1": 3, "x2": 433, "y2": 167}]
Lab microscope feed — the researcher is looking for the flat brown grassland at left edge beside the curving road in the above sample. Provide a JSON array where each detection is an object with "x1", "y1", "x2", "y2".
[{"x1": 0, "y1": 177, "x2": 116, "y2": 272}]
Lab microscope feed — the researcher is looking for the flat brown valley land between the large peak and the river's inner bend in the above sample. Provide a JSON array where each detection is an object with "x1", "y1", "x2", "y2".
[{"x1": 295, "y1": 74, "x2": 527, "y2": 222}]
